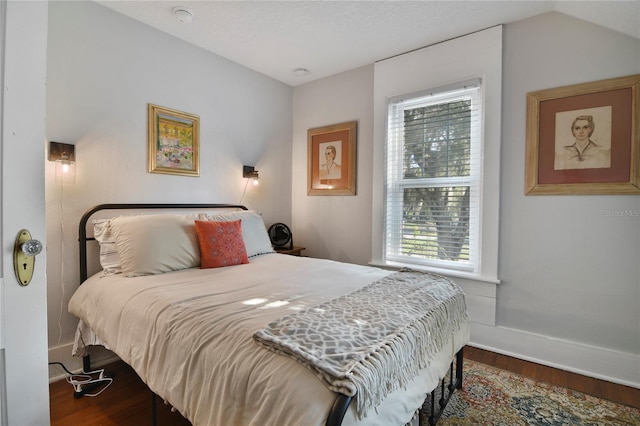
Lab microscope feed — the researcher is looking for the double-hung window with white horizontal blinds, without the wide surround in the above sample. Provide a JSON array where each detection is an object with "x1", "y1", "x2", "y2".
[{"x1": 384, "y1": 79, "x2": 482, "y2": 274}]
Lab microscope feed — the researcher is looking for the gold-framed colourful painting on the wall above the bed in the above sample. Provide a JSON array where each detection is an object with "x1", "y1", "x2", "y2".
[{"x1": 147, "y1": 104, "x2": 200, "y2": 176}]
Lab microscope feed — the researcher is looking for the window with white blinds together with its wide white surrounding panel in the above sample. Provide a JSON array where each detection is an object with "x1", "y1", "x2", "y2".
[{"x1": 370, "y1": 26, "x2": 502, "y2": 282}]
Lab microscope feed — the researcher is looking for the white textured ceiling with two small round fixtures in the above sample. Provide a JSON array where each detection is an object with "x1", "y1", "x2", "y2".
[{"x1": 97, "y1": 0, "x2": 640, "y2": 86}]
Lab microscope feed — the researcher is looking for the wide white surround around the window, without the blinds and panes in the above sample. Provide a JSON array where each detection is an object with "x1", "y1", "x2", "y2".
[{"x1": 369, "y1": 25, "x2": 504, "y2": 284}]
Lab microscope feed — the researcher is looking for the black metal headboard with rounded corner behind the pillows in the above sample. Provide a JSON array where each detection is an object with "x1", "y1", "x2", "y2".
[{"x1": 78, "y1": 204, "x2": 248, "y2": 284}]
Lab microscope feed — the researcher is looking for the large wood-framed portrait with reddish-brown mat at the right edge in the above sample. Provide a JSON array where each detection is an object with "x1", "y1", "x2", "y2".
[{"x1": 525, "y1": 74, "x2": 640, "y2": 195}]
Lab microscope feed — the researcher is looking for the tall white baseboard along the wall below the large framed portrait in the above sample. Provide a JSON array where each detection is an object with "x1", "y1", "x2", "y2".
[{"x1": 470, "y1": 322, "x2": 640, "y2": 388}]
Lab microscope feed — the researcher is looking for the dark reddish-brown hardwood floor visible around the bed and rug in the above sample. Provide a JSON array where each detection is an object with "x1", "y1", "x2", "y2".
[{"x1": 50, "y1": 347, "x2": 640, "y2": 426}]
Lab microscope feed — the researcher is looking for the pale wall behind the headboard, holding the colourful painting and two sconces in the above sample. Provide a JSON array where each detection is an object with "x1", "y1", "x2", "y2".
[{"x1": 46, "y1": 2, "x2": 292, "y2": 376}]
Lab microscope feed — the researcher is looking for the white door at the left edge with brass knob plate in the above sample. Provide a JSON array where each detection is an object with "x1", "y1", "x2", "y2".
[{"x1": 0, "y1": 1, "x2": 49, "y2": 426}]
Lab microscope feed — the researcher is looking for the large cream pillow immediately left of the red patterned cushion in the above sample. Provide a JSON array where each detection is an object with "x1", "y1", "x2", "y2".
[{"x1": 110, "y1": 214, "x2": 200, "y2": 277}]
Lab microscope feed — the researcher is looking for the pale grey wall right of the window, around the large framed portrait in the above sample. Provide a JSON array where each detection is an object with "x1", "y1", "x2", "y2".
[{"x1": 490, "y1": 13, "x2": 640, "y2": 383}]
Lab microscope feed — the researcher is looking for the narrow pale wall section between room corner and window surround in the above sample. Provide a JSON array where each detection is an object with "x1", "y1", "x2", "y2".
[{"x1": 292, "y1": 65, "x2": 373, "y2": 264}]
